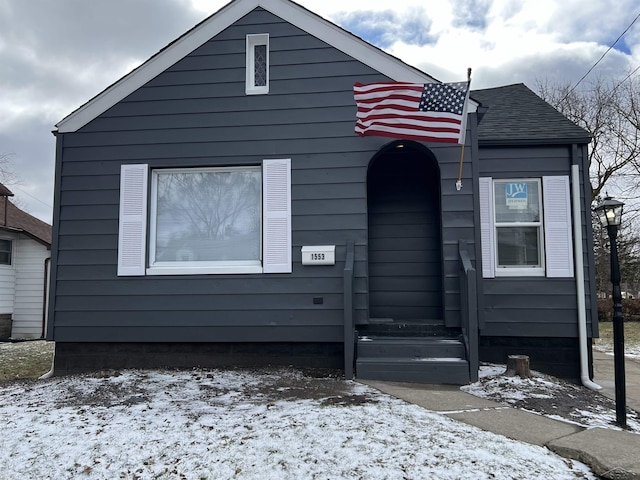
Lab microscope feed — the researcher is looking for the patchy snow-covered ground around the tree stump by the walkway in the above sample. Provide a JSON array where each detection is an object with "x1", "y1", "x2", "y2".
[{"x1": 461, "y1": 364, "x2": 640, "y2": 433}]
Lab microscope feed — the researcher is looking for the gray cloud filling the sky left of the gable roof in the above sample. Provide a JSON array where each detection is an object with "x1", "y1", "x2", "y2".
[{"x1": 0, "y1": 0, "x2": 203, "y2": 221}]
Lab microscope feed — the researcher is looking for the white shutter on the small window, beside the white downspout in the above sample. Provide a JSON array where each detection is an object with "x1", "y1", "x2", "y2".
[{"x1": 542, "y1": 175, "x2": 573, "y2": 277}]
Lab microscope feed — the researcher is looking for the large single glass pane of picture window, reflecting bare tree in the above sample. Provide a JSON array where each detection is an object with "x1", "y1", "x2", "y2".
[{"x1": 153, "y1": 167, "x2": 262, "y2": 262}]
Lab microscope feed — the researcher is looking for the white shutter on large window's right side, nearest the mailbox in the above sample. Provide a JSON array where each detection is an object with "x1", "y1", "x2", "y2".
[{"x1": 262, "y1": 158, "x2": 291, "y2": 273}]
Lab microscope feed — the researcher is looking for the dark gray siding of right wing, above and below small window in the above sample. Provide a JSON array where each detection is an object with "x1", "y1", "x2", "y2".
[{"x1": 479, "y1": 145, "x2": 597, "y2": 337}]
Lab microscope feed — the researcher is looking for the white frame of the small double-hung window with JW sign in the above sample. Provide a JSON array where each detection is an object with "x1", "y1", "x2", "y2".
[{"x1": 491, "y1": 178, "x2": 545, "y2": 277}]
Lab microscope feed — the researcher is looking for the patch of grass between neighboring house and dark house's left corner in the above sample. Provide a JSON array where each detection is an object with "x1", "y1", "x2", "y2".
[{"x1": 0, "y1": 340, "x2": 55, "y2": 381}]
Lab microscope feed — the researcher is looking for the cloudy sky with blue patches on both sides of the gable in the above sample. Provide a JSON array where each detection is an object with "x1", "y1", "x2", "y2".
[{"x1": 0, "y1": 0, "x2": 640, "y2": 222}]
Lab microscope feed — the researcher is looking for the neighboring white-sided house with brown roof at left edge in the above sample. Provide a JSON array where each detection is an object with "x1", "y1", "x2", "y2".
[{"x1": 0, "y1": 184, "x2": 51, "y2": 339}]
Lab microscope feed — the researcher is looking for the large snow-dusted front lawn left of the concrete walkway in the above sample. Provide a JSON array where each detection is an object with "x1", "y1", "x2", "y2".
[{"x1": 0, "y1": 369, "x2": 595, "y2": 480}]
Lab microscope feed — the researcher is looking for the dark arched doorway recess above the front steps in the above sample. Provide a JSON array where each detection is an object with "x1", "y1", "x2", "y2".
[{"x1": 367, "y1": 141, "x2": 443, "y2": 323}]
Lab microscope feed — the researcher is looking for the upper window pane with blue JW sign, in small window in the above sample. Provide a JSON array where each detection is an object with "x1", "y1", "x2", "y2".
[{"x1": 494, "y1": 180, "x2": 540, "y2": 223}]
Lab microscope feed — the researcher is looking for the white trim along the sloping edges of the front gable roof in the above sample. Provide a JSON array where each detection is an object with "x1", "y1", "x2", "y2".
[{"x1": 56, "y1": 0, "x2": 477, "y2": 133}]
